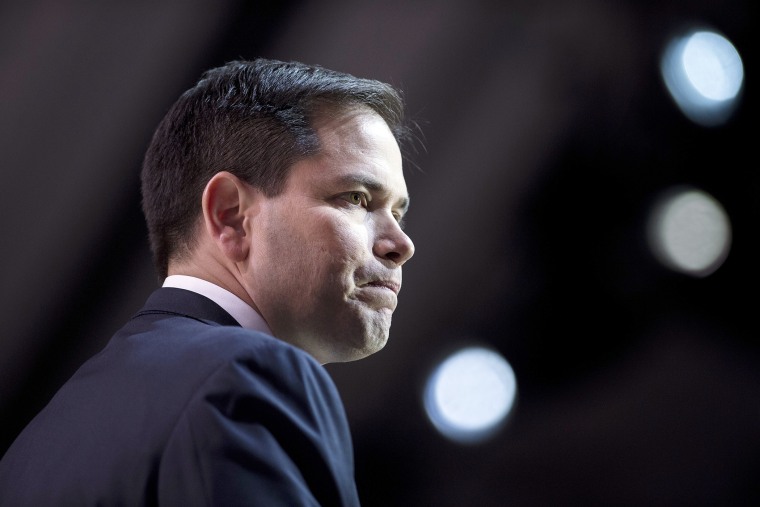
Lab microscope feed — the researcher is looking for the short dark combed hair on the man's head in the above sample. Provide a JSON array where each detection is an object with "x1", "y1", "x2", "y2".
[{"x1": 141, "y1": 59, "x2": 411, "y2": 278}]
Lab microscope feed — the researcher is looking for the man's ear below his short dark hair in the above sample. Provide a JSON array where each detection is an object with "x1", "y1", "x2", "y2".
[{"x1": 202, "y1": 171, "x2": 251, "y2": 262}]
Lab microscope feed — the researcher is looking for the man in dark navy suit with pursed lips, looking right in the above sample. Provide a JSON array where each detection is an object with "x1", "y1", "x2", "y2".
[{"x1": 0, "y1": 59, "x2": 414, "y2": 507}]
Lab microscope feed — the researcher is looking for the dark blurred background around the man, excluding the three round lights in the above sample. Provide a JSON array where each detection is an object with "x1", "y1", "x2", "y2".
[{"x1": 0, "y1": 0, "x2": 760, "y2": 507}]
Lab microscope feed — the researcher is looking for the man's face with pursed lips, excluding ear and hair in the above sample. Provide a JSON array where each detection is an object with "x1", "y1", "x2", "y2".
[{"x1": 243, "y1": 110, "x2": 414, "y2": 363}]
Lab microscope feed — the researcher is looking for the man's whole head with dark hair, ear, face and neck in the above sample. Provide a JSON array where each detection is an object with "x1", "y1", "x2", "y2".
[{"x1": 142, "y1": 60, "x2": 414, "y2": 362}]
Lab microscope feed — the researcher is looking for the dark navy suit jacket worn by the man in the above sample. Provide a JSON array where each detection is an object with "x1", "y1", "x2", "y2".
[{"x1": 0, "y1": 288, "x2": 359, "y2": 507}]
